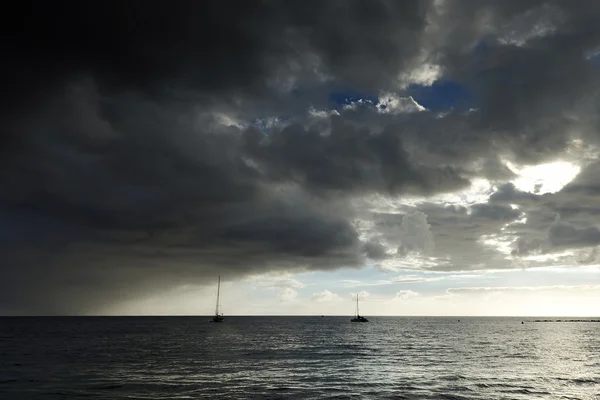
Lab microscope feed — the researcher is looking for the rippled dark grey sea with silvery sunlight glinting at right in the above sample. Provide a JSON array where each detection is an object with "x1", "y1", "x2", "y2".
[{"x1": 0, "y1": 315, "x2": 600, "y2": 400}]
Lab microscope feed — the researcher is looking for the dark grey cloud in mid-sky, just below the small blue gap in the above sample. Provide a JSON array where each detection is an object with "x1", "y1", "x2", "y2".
[{"x1": 241, "y1": 117, "x2": 469, "y2": 194}]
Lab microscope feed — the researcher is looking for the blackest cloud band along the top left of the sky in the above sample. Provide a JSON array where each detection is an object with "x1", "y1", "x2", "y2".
[{"x1": 2, "y1": 1, "x2": 429, "y2": 112}]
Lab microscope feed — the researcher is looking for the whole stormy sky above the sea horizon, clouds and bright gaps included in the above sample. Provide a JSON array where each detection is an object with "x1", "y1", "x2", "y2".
[{"x1": 0, "y1": 0, "x2": 600, "y2": 316}]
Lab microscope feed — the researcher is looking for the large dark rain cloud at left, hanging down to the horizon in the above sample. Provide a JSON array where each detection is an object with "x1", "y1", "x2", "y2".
[{"x1": 0, "y1": 83, "x2": 363, "y2": 313}]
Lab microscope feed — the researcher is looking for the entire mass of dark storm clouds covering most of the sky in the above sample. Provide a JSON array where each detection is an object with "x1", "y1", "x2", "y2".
[{"x1": 0, "y1": 1, "x2": 600, "y2": 313}]
